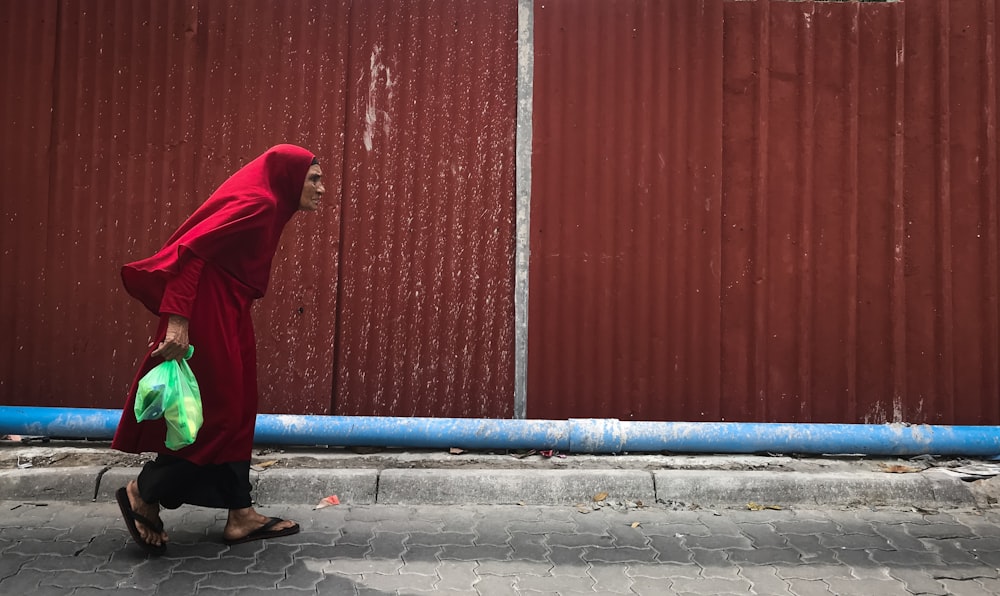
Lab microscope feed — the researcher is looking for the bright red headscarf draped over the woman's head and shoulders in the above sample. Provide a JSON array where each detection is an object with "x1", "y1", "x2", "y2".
[{"x1": 122, "y1": 145, "x2": 315, "y2": 314}]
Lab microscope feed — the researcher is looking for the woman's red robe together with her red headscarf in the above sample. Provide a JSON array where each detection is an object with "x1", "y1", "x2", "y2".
[{"x1": 111, "y1": 145, "x2": 314, "y2": 465}]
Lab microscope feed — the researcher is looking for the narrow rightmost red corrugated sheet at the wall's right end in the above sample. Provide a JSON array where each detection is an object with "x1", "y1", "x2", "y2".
[{"x1": 908, "y1": 0, "x2": 1000, "y2": 424}]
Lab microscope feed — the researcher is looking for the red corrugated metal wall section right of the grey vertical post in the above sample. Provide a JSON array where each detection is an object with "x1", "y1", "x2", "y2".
[{"x1": 528, "y1": 0, "x2": 1000, "y2": 424}]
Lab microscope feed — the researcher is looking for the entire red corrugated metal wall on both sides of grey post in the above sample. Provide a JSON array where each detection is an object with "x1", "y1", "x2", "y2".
[{"x1": 0, "y1": 0, "x2": 1000, "y2": 424}]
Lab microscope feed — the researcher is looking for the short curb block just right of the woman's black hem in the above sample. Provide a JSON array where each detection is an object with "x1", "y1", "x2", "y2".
[{"x1": 250, "y1": 469, "x2": 379, "y2": 505}]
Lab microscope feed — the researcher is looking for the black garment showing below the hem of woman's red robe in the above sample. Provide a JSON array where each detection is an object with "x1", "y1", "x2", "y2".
[{"x1": 137, "y1": 453, "x2": 252, "y2": 509}]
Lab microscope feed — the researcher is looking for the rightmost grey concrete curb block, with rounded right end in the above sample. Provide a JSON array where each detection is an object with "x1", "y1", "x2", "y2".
[{"x1": 653, "y1": 470, "x2": 976, "y2": 508}]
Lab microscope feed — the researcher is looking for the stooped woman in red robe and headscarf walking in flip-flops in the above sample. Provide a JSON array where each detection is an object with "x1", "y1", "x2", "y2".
[{"x1": 111, "y1": 145, "x2": 325, "y2": 554}]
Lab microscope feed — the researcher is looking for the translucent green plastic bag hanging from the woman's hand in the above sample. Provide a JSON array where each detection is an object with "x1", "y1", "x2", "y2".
[{"x1": 135, "y1": 346, "x2": 203, "y2": 451}]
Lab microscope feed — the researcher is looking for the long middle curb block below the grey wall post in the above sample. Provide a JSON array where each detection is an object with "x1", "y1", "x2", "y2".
[{"x1": 378, "y1": 469, "x2": 655, "y2": 505}]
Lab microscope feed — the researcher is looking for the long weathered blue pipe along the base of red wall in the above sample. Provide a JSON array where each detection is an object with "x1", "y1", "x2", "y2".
[{"x1": 0, "y1": 406, "x2": 1000, "y2": 457}]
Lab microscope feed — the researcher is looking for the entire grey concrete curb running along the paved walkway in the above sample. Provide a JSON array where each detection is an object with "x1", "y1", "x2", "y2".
[{"x1": 0, "y1": 466, "x2": 977, "y2": 509}]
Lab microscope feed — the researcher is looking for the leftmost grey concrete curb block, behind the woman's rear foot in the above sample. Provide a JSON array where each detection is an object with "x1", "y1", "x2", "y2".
[{"x1": 0, "y1": 466, "x2": 105, "y2": 502}]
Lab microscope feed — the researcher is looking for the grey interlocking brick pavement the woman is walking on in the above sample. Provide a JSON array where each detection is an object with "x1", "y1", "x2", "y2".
[{"x1": 0, "y1": 500, "x2": 1000, "y2": 596}]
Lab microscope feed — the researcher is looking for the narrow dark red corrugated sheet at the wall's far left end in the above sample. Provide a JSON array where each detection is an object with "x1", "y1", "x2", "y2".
[{"x1": 0, "y1": 0, "x2": 57, "y2": 412}]
